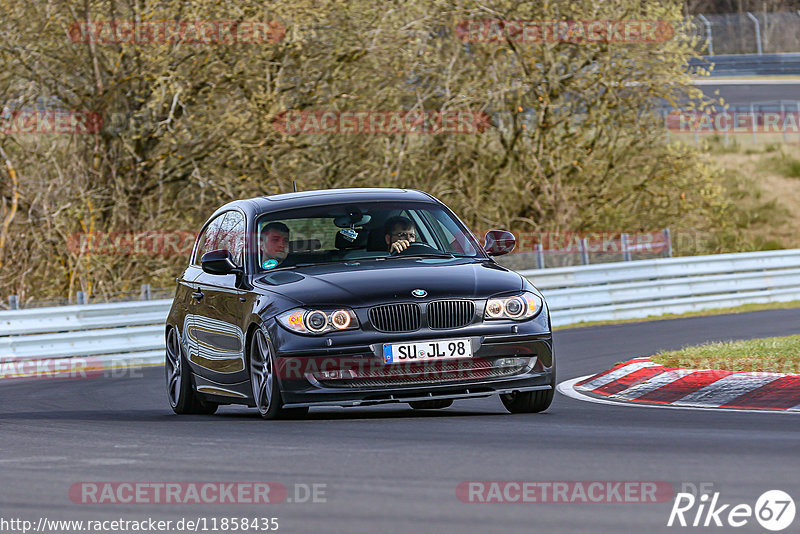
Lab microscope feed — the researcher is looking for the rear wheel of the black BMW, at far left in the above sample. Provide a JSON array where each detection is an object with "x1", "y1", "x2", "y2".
[{"x1": 164, "y1": 326, "x2": 219, "y2": 415}]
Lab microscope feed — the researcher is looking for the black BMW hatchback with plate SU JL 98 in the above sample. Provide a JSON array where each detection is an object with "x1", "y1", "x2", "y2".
[{"x1": 165, "y1": 189, "x2": 556, "y2": 419}]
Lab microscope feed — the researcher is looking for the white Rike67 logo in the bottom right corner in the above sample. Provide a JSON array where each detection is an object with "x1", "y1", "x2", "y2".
[{"x1": 667, "y1": 490, "x2": 795, "y2": 532}]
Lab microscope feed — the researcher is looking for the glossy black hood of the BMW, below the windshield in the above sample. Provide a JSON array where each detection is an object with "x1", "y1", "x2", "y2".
[{"x1": 254, "y1": 258, "x2": 523, "y2": 307}]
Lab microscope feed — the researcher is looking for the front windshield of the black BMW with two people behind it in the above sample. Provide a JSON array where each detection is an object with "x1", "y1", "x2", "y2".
[{"x1": 256, "y1": 202, "x2": 485, "y2": 271}]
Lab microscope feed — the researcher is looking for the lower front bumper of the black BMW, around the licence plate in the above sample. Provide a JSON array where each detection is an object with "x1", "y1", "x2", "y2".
[{"x1": 268, "y1": 326, "x2": 555, "y2": 408}]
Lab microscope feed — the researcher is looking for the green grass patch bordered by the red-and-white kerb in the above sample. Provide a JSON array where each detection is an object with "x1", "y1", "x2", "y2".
[{"x1": 652, "y1": 335, "x2": 800, "y2": 373}]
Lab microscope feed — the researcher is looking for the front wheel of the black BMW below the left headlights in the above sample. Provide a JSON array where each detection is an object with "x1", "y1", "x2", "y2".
[{"x1": 250, "y1": 328, "x2": 308, "y2": 419}]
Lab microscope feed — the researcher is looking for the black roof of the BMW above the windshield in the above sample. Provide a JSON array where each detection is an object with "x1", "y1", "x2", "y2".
[{"x1": 214, "y1": 187, "x2": 438, "y2": 220}]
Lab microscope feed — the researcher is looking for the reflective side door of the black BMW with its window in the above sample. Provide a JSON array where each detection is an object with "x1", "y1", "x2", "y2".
[{"x1": 192, "y1": 211, "x2": 247, "y2": 395}]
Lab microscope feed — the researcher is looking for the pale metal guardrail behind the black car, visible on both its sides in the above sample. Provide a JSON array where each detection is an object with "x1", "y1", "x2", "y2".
[{"x1": 0, "y1": 249, "x2": 800, "y2": 377}]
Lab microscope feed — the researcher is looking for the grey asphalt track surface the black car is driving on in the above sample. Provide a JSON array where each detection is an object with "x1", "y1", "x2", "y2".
[{"x1": 0, "y1": 310, "x2": 800, "y2": 534}]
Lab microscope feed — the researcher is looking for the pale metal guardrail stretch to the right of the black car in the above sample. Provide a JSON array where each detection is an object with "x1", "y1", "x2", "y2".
[{"x1": 520, "y1": 250, "x2": 800, "y2": 326}]
